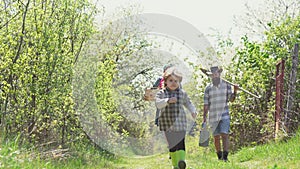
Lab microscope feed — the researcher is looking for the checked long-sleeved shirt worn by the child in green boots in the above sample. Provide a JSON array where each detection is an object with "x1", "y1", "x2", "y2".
[{"x1": 155, "y1": 88, "x2": 196, "y2": 131}]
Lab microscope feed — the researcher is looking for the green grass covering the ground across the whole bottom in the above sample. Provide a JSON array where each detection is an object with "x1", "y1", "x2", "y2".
[{"x1": 0, "y1": 132, "x2": 300, "y2": 169}]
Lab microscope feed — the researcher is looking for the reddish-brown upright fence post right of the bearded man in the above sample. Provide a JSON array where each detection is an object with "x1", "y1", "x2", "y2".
[{"x1": 275, "y1": 60, "x2": 285, "y2": 139}]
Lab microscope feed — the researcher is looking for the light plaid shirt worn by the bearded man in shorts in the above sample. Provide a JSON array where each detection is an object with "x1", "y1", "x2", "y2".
[{"x1": 204, "y1": 80, "x2": 232, "y2": 122}]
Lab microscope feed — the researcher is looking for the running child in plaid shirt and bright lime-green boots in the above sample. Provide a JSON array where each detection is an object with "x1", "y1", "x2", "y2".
[{"x1": 156, "y1": 67, "x2": 197, "y2": 169}]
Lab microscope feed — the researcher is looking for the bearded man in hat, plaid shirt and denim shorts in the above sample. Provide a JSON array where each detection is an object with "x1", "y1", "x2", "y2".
[{"x1": 203, "y1": 66, "x2": 238, "y2": 161}]
